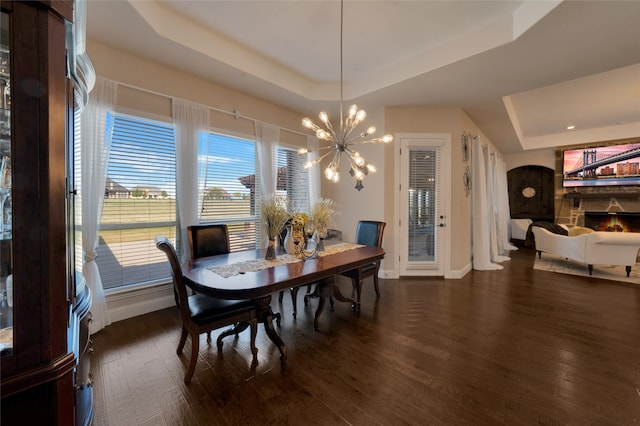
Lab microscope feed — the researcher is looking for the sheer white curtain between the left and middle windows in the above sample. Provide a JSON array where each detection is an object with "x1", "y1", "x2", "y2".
[{"x1": 171, "y1": 99, "x2": 209, "y2": 261}]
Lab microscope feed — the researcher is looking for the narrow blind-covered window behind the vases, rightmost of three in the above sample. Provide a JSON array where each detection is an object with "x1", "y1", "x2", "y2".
[{"x1": 277, "y1": 147, "x2": 309, "y2": 213}]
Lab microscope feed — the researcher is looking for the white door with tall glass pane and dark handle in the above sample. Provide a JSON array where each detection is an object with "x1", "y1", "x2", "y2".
[{"x1": 398, "y1": 134, "x2": 451, "y2": 276}]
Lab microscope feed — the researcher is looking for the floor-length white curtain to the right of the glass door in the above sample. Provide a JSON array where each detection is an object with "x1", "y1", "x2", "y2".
[{"x1": 471, "y1": 135, "x2": 513, "y2": 271}]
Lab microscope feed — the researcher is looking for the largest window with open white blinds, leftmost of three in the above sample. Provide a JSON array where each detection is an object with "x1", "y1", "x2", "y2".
[{"x1": 96, "y1": 114, "x2": 177, "y2": 289}]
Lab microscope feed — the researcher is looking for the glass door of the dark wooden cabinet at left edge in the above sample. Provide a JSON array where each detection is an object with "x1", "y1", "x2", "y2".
[{"x1": 0, "y1": 13, "x2": 13, "y2": 355}]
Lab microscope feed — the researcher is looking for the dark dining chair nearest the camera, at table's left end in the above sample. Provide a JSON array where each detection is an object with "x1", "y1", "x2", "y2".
[{"x1": 156, "y1": 235, "x2": 258, "y2": 385}]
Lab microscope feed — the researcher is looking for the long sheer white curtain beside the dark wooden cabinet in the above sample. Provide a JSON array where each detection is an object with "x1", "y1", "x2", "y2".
[{"x1": 80, "y1": 78, "x2": 117, "y2": 334}]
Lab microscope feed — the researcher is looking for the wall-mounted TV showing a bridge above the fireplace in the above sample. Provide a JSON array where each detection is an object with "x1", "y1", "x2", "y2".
[{"x1": 562, "y1": 142, "x2": 640, "y2": 187}]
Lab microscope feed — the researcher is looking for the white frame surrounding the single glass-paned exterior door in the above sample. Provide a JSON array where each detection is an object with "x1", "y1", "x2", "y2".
[{"x1": 393, "y1": 133, "x2": 452, "y2": 278}]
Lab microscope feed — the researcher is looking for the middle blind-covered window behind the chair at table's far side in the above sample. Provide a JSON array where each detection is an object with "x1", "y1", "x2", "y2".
[{"x1": 199, "y1": 133, "x2": 260, "y2": 251}]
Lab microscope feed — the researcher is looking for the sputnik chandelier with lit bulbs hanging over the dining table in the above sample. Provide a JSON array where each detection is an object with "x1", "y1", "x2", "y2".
[{"x1": 298, "y1": 0, "x2": 393, "y2": 191}]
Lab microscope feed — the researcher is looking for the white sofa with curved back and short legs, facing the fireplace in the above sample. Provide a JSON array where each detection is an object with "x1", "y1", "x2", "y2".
[{"x1": 531, "y1": 226, "x2": 640, "y2": 277}]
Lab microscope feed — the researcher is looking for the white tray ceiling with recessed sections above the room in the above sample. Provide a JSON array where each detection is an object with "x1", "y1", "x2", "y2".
[{"x1": 87, "y1": 0, "x2": 640, "y2": 154}]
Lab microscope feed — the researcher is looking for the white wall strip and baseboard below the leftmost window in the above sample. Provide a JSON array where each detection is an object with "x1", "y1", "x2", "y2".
[{"x1": 106, "y1": 283, "x2": 176, "y2": 323}]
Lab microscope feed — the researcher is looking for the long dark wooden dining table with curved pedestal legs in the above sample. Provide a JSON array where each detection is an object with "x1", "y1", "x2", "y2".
[{"x1": 182, "y1": 246, "x2": 385, "y2": 364}]
